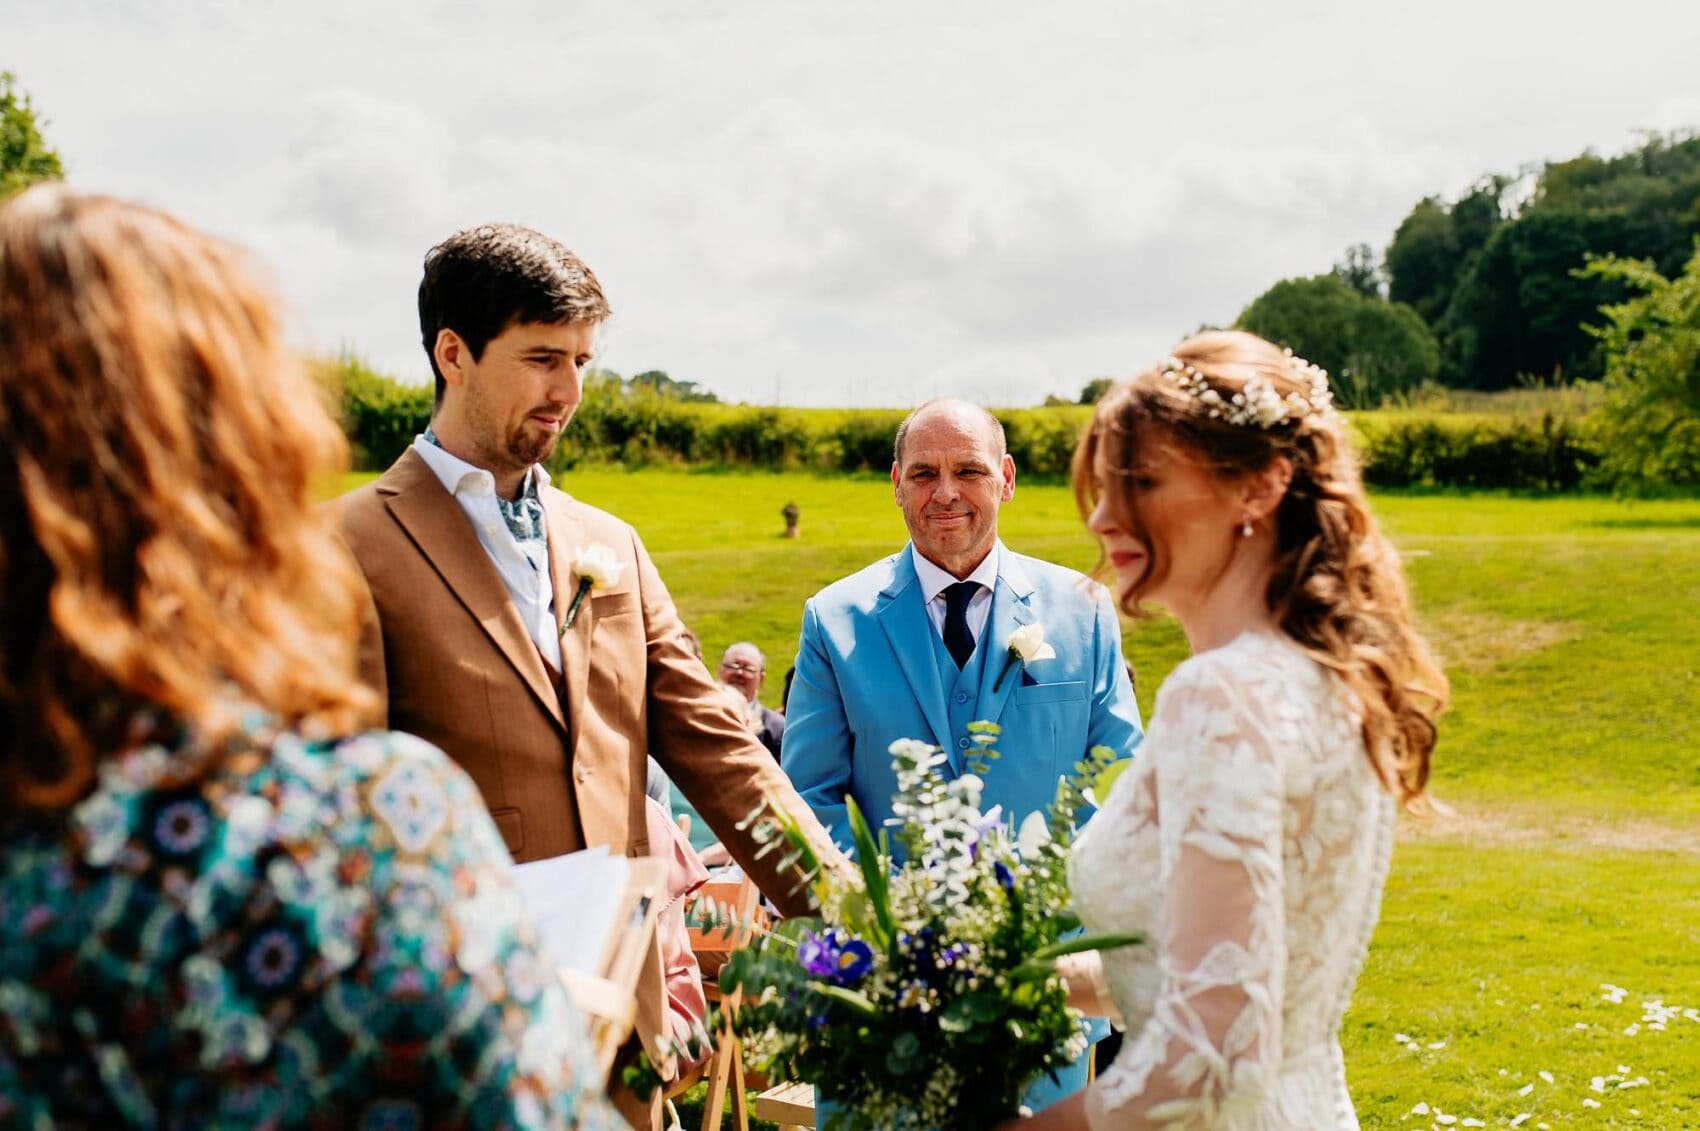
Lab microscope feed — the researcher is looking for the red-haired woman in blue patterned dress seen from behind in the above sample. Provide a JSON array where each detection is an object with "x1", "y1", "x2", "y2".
[{"x1": 0, "y1": 185, "x2": 617, "y2": 1128}]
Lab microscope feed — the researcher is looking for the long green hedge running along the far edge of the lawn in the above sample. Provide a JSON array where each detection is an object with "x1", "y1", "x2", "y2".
[{"x1": 321, "y1": 359, "x2": 1601, "y2": 492}]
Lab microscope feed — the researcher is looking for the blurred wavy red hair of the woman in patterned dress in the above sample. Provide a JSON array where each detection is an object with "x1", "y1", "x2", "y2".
[{"x1": 0, "y1": 185, "x2": 376, "y2": 813}]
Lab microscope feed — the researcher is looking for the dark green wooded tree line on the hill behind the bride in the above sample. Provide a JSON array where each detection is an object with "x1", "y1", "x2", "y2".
[{"x1": 1236, "y1": 134, "x2": 1700, "y2": 406}]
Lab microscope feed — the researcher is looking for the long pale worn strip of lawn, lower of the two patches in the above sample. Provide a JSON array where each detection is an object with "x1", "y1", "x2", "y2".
[{"x1": 1399, "y1": 804, "x2": 1700, "y2": 857}]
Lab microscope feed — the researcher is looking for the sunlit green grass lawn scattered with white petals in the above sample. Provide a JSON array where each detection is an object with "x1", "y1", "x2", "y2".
[{"x1": 331, "y1": 469, "x2": 1700, "y2": 1128}]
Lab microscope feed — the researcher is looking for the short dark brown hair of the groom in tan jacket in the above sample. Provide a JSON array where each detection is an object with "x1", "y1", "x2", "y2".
[{"x1": 420, "y1": 224, "x2": 609, "y2": 410}]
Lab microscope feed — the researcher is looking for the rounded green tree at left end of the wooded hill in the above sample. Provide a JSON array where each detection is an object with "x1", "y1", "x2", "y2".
[{"x1": 1236, "y1": 274, "x2": 1440, "y2": 408}]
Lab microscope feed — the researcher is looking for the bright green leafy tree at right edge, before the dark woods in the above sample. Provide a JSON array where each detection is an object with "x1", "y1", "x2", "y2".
[{"x1": 1583, "y1": 243, "x2": 1700, "y2": 492}]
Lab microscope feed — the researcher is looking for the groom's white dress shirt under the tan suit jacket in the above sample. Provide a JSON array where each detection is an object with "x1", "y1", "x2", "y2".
[{"x1": 413, "y1": 435, "x2": 561, "y2": 672}]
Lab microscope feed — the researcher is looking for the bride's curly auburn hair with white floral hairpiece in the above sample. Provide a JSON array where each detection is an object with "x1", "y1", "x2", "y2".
[{"x1": 1073, "y1": 332, "x2": 1448, "y2": 808}]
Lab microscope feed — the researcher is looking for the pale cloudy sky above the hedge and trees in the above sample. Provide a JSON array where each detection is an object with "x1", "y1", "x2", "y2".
[{"x1": 0, "y1": 0, "x2": 1700, "y2": 405}]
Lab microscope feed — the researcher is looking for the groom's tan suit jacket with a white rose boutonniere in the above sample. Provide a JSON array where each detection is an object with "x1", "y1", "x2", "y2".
[{"x1": 330, "y1": 449, "x2": 831, "y2": 1095}]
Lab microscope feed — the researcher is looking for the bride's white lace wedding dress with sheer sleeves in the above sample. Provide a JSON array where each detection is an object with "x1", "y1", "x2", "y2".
[{"x1": 1069, "y1": 633, "x2": 1394, "y2": 1131}]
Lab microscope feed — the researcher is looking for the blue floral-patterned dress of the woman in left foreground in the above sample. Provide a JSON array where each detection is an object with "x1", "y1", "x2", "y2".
[{"x1": 0, "y1": 700, "x2": 624, "y2": 1131}]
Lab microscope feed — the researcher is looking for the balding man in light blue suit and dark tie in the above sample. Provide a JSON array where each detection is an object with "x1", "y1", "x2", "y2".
[{"x1": 782, "y1": 400, "x2": 1141, "y2": 1109}]
